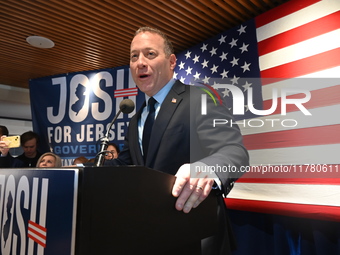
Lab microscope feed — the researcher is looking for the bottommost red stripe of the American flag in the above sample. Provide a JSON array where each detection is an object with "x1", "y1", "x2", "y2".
[{"x1": 225, "y1": 198, "x2": 340, "y2": 221}]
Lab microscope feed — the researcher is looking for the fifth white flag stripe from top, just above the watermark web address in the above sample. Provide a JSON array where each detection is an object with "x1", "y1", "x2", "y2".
[{"x1": 248, "y1": 143, "x2": 340, "y2": 165}]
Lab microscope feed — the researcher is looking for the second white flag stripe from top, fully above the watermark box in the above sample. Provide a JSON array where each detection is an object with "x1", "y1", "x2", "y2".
[{"x1": 259, "y1": 29, "x2": 340, "y2": 71}]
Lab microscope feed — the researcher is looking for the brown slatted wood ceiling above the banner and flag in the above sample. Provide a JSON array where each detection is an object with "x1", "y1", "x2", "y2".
[{"x1": 0, "y1": 0, "x2": 287, "y2": 88}]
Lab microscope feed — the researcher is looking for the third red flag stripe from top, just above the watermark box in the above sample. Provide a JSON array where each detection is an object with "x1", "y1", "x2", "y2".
[{"x1": 261, "y1": 48, "x2": 340, "y2": 78}]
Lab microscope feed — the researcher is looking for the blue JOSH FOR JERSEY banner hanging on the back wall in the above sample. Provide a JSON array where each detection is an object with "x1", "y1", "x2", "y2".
[{"x1": 30, "y1": 66, "x2": 145, "y2": 166}]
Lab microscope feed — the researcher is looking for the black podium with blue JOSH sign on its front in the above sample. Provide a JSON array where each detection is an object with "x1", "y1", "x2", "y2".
[{"x1": 0, "y1": 166, "x2": 218, "y2": 255}]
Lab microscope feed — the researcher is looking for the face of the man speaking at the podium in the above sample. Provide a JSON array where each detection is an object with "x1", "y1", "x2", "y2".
[{"x1": 130, "y1": 32, "x2": 176, "y2": 97}]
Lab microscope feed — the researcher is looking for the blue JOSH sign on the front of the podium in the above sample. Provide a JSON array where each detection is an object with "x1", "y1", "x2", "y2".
[{"x1": 0, "y1": 168, "x2": 79, "y2": 255}]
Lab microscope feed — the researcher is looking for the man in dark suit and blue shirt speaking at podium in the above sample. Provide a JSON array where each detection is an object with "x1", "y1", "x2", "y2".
[{"x1": 105, "y1": 27, "x2": 248, "y2": 255}]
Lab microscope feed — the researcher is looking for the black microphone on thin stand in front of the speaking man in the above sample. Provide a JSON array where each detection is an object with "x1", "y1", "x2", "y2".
[{"x1": 94, "y1": 99, "x2": 135, "y2": 166}]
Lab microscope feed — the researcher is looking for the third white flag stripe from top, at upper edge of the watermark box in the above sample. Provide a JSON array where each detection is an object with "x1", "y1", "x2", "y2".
[{"x1": 262, "y1": 74, "x2": 340, "y2": 101}]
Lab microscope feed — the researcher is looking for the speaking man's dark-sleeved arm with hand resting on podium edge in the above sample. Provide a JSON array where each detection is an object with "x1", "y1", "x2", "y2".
[{"x1": 172, "y1": 89, "x2": 249, "y2": 212}]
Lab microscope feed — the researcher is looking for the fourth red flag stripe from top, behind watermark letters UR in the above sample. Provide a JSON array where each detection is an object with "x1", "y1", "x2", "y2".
[{"x1": 263, "y1": 85, "x2": 340, "y2": 115}]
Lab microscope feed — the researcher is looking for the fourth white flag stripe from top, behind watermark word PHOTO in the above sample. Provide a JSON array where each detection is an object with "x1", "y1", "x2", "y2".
[{"x1": 236, "y1": 105, "x2": 340, "y2": 135}]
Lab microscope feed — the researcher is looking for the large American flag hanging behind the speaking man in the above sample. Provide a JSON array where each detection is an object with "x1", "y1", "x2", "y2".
[{"x1": 174, "y1": 0, "x2": 340, "y2": 221}]
